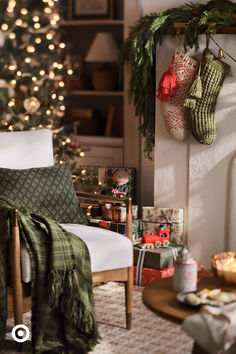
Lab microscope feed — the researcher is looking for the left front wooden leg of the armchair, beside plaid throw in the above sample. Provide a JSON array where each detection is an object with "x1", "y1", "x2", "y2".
[{"x1": 12, "y1": 209, "x2": 23, "y2": 351}]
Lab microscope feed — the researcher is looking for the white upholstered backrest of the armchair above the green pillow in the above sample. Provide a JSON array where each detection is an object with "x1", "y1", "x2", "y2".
[{"x1": 0, "y1": 129, "x2": 54, "y2": 169}]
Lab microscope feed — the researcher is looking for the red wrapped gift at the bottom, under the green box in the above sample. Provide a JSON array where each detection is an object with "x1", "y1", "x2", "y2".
[{"x1": 134, "y1": 267, "x2": 174, "y2": 286}]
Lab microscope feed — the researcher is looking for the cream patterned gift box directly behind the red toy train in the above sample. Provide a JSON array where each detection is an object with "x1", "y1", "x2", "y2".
[{"x1": 142, "y1": 207, "x2": 184, "y2": 245}]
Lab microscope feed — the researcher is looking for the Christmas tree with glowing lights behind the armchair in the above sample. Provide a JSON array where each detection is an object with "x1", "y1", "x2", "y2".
[{"x1": 0, "y1": 0, "x2": 83, "y2": 162}]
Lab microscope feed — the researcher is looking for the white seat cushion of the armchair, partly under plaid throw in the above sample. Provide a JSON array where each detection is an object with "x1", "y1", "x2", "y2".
[{"x1": 21, "y1": 224, "x2": 133, "y2": 283}]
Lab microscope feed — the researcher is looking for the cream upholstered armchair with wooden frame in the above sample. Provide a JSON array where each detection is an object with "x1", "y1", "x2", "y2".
[{"x1": 0, "y1": 129, "x2": 133, "y2": 329}]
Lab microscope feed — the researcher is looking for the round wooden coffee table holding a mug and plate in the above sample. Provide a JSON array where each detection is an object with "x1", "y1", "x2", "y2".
[{"x1": 143, "y1": 272, "x2": 236, "y2": 323}]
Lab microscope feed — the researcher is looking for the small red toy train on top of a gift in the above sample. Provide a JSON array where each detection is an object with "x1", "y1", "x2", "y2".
[{"x1": 138, "y1": 224, "x2": 170, "y2": 248}]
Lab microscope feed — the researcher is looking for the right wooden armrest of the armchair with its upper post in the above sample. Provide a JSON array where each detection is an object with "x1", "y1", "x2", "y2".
[{"x1": 76, "y1": 191, "x2": 133, "y2": 242}]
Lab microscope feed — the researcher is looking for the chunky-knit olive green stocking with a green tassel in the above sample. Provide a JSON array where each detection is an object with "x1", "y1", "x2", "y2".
[{"x1": 184, "y1": 48, "x2": 230, "y2": 145}]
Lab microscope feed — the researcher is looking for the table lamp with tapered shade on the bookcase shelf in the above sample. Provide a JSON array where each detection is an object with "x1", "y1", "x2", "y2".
[{"x1": 85, "y1": 32, "x2": 119, "y2": 91}]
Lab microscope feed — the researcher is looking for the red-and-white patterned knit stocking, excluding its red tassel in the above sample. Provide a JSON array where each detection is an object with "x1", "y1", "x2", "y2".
[{"x1": 161, "y1": 48, "x2": 197, "y2": 141}]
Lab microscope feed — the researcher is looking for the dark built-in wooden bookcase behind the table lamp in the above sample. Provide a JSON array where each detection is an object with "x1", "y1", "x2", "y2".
[{"x1": 59, "y1": 0, "x2": 126, "y2": 167}]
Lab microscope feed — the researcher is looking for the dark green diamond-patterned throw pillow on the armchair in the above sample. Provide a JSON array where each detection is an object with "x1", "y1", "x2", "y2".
[{"x1": 0, "y1": 162, "x2": 87, "y2": 224}]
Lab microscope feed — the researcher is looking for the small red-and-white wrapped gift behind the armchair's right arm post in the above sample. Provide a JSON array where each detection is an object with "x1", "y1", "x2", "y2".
[{"x1": 102, "y1": 205, "x2": 138, "y2": 223}]
